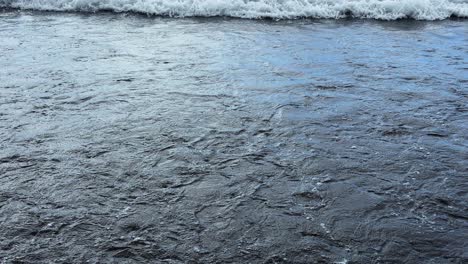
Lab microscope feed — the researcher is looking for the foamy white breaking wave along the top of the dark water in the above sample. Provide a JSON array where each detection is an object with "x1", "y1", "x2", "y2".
[{"x1": 0, "y1": 0, "x2": 468, "y2": 20}]
